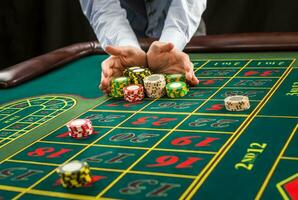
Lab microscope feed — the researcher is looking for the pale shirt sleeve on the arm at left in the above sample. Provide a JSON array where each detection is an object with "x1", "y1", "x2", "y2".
[{"x1": 80, "y1": 0, "x2": 140, "y2": 48}]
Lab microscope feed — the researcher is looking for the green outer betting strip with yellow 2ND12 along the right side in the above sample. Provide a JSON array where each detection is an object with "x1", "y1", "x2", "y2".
[{"x1": 188, "y1": 61, "x2": 298, "y2": 199}]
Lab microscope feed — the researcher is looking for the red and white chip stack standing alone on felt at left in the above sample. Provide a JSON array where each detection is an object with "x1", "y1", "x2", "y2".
[{"x1": 66, "y1": 119, "x2": 93, "y2": 138}]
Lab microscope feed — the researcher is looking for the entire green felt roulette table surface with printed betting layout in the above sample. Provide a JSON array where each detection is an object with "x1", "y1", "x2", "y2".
[{"x1": 0, "y1": 52, "x2": 298, "y2": 200}]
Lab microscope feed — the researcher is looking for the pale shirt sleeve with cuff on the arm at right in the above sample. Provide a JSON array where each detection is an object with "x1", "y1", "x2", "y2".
[{"x1": 159, "y1": 0, "x2": 207, "y2": 51}]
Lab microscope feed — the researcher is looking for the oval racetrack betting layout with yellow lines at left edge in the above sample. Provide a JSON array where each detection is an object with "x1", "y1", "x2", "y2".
[{"x1": 0, "y1": 96, "x2": 76, "y2": 149}]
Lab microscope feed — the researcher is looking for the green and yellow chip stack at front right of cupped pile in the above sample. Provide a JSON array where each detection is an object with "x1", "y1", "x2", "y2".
[{"x1": 166, "y1": 81, "x2": 188, "y2": 98}]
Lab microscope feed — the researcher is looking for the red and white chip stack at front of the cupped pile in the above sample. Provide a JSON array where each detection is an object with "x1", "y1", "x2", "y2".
[{"x1": 123, "y1": 84, "x2": 145, "y2": 102}]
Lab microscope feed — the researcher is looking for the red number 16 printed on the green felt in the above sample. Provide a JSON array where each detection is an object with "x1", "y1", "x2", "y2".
[{"x1": 146, "y1": 156, "x2": 202, "y2": 169}]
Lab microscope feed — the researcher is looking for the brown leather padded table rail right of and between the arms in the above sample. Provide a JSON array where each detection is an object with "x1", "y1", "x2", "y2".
[{"x1": 140, "y1": 32, "x2": 298, "y2": 53}]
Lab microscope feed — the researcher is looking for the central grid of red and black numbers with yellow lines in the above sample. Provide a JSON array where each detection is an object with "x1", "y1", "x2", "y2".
[{"x1": 0, "y1": 57, "x2": 292, "y2": 198}]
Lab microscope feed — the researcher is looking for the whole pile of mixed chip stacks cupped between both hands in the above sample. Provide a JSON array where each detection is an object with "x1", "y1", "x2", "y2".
[{"x1": 110, "y1": 66, "x2": 188, "y2": 102}]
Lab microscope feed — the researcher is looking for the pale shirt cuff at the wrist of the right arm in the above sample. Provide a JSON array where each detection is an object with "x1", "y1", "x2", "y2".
[{"x1": 159, "y1": 28, "x2": 188, "y2": 51}]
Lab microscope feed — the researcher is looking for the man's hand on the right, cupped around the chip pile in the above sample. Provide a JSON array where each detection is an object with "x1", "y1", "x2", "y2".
[{"x1": 147, "y1": 41, "x2": 199, "y2": 85}]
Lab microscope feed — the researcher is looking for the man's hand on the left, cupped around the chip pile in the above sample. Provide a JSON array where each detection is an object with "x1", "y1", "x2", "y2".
[{"x1": 99, "y1": 46, "x2": 147, "y2": 94}]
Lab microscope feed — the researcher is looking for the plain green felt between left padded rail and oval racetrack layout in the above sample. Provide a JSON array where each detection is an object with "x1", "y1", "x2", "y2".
[{"x1": 0, "y1": 56, "x2": 106, "y2": 103}]
